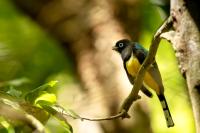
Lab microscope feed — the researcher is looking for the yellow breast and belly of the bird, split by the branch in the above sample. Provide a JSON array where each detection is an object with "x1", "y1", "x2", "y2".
[{"x1": 126, "y1": 55, "x2": 160, "y2": 93}]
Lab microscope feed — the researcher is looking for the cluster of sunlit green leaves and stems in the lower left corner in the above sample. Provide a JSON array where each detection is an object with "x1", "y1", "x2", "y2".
[{"x1": 0, "y1": 81, "x2": 76, "y2": 133}]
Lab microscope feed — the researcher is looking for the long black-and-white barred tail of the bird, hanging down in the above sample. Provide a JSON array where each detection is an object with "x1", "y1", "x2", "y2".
[{"x1": 158, "y1": 94, "x2": 174, "y2": 127}]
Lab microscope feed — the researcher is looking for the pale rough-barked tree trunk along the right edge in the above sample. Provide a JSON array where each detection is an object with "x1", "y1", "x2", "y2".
[{"x1": 163, "y1": 0, "x2": 200, "y2": 133}]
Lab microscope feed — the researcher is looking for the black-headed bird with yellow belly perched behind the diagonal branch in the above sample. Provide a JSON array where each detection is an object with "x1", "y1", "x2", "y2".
[{"x1": 112, "y1": 39, "x2": 174, "y2": 128}]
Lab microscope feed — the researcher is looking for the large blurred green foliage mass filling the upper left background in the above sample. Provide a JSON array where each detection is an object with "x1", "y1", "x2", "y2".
[{"x1": 0, "y1": 0, "x2": 73, "y2": 89}]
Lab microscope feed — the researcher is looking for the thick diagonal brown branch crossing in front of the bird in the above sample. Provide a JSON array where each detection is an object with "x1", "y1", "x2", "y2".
[{"x1": 120, "y1": 16, "x2": 172, "y2": 117}]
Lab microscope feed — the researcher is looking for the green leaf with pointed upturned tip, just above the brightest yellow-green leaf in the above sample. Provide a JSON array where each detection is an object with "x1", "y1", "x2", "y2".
[{"x1": 25, "y1": 81, "x2": 58, "y2": 103}]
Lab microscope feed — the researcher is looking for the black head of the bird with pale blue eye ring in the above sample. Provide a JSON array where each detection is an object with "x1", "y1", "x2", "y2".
[{"x1": 112, "y1": 39, "x2": 130, "y2": 53}]
